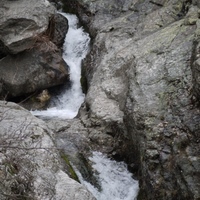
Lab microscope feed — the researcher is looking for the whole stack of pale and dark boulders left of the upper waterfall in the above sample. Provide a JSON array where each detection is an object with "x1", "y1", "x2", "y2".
[{"x1": 0, "y1": 0, "x2": 69, "y2": 104}]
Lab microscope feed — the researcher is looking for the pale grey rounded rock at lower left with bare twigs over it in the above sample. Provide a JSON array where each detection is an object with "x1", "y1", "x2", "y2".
[{"x1": 0, "y1": 101, "x2": 95, "y2": 200}]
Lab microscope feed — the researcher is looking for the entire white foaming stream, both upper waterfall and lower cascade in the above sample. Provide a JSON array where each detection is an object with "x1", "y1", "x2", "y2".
[{"x1": 32, "y1": 13, "x2": 139, "y2": 200}]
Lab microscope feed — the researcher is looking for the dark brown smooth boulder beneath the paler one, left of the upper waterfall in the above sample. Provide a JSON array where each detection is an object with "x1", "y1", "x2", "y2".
[{"x1": 0, "y1": 41, "x2": 69, "y2": 98}]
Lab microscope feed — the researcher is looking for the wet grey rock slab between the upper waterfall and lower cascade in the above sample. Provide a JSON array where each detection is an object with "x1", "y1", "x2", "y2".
[{"x1": 46, "y1": 119, "x2": 102, "y2": 188}]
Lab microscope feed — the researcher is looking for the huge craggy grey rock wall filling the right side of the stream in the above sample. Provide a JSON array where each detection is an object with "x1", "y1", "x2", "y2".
[{"x1": 63, "y1": 0, "x2": 200, "y2": 200}]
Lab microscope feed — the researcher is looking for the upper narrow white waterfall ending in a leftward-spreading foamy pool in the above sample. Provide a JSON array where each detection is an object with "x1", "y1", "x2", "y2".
[{"x1": 32, "y1": 13, "x2": 90, "y2": 119}]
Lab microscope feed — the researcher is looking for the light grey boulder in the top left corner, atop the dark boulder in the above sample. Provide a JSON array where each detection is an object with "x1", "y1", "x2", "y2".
[{"x1": 0, "y1": 0, "x2": 56, "y2": 54}]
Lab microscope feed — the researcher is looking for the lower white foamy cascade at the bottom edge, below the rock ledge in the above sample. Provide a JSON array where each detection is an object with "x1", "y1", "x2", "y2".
[{"x1": 77, "y1": 152, "x2": 139, "y2": 200}]
